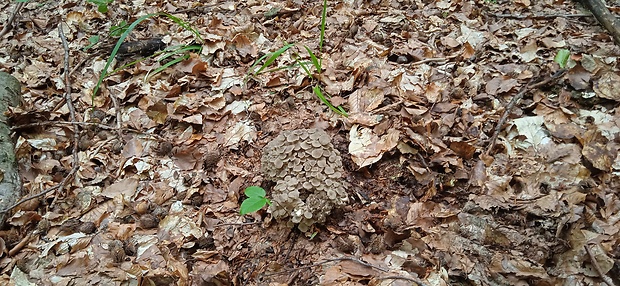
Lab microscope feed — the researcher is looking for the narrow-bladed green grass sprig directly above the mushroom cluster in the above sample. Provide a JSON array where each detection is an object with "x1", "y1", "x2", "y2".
[{"x1": 250, "y1": 0, "x2": 348, "y2": 117}]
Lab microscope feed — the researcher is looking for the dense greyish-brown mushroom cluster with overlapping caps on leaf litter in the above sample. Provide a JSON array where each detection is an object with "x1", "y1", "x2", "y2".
[{"x1": 261, "y1": 129, "x2": 349, "y2": 232}]
